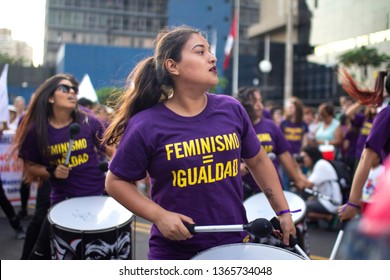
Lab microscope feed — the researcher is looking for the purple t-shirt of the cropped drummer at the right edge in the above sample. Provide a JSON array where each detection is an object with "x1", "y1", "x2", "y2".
[{"x1": 366, "y1": 106, "x2": 390, "y2": 162}]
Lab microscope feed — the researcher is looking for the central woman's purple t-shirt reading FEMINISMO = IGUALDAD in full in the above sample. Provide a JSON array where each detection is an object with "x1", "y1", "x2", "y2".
[{"x1": 109, "y1": 94, "x2": 261, "y2": 259}]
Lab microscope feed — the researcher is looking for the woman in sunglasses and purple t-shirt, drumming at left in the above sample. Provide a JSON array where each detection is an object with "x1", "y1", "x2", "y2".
[{"x1": 13, "y1": 74, "x2": 111, "y2": 259}]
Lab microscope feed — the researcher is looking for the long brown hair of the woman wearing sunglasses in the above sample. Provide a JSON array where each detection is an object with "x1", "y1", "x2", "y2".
[{"x1": 11, "y1": 73, "x2": 83, "y2": 155}]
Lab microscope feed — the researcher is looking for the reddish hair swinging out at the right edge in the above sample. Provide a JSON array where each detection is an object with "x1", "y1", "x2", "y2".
[{"x1": 341, "y1": 68, "x2": 390, "y2": 106}]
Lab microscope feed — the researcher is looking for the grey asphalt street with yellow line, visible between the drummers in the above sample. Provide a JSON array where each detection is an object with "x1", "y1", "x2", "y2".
[{"x1": 0, "y1": 203, "x2": 339, "y2": 260}]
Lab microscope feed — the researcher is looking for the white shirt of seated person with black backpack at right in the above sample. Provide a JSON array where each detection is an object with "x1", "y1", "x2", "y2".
[{"x1": 308, "y1": 159, "x2": 342, "y2": 214}]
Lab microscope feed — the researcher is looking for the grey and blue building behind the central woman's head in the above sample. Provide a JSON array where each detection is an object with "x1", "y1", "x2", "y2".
[{"x1": 44, "y1": 0, "x2": 259, "y2": 94}]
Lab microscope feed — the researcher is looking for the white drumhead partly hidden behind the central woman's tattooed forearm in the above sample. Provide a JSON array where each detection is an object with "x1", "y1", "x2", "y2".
[{"x1": 244, "y1": 191, "x2": 306, "y2": 224}]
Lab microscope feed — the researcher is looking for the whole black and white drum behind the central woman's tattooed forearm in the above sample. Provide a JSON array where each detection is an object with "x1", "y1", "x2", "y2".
[{"x1": 244, "y1": 191, "x2": 310, "y2": 255}]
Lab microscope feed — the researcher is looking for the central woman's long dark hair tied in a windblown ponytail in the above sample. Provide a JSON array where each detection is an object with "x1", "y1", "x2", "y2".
[{"x1": 103, "y1": 26, "x2": 201, "y2": 145}]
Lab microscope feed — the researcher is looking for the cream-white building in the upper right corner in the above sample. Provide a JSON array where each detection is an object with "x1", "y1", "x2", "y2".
[{"x1": 306, "y1": 0, "x2": 390, "y2": 82}]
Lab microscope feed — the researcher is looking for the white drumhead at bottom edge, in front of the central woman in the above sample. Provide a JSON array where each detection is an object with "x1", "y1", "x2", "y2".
[{"x1": 192, "y1": 243, "x2": 305, "y2": 260}]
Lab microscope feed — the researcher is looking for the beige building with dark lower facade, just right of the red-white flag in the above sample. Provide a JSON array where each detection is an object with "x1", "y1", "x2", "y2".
[{"x1": 248, "y1": 0, "x2": 316, "y2": 105}]
